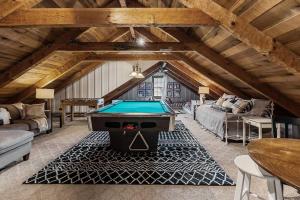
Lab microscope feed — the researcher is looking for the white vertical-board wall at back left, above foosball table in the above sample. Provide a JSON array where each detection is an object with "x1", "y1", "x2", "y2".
[{"x1": 53, "y1": 61, "x2": 155, "y2": 112}]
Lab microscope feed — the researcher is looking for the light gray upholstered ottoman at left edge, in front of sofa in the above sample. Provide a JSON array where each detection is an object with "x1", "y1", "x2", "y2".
[{"x1": 0, "y1": 130, "x2": 34, "y2": 169}]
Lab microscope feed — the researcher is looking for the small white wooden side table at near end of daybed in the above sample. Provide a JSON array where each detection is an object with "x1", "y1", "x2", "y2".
[{"x1": 243, "y1": 116, "x2": 272, "y2": 146}]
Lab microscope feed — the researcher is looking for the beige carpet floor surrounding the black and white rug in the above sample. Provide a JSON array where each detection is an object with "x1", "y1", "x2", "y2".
[{"x1": 0, "y1": 114, "x2": 300, "y2": 200}]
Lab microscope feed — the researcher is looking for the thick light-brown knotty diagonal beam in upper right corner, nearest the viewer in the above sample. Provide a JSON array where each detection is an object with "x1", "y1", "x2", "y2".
[{"x1": 180, "y1": 0, "x2": 300, "y2": 73}]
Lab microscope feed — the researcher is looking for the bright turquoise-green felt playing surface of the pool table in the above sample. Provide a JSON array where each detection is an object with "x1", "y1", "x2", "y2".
[{"x1": 97, "y1": 101, "x2": 170, "y2": 113}]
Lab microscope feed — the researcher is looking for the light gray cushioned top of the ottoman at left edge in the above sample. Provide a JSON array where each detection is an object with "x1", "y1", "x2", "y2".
[{"x1": 0, "y1": 130, "x2": 33, "y2": 154}]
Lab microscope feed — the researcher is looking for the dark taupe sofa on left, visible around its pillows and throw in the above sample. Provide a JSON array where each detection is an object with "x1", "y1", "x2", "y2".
[{"x1": 0, "y1": 104, "x2": 51, "y2": 135}]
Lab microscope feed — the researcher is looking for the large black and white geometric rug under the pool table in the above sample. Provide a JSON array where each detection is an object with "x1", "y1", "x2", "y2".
[{"x1": 24, "y1": 121, "x2": 234, "y2": 186}]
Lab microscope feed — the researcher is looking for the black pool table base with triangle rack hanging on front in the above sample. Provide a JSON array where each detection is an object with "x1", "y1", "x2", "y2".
[{"x1": 91, "y1": 116, "x2": 173, "y2": 152}]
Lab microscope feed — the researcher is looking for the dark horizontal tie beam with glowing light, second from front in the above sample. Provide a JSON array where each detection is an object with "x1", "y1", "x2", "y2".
[{"x1": 57, "y1": 42, "x2": 191, "y2": 52}]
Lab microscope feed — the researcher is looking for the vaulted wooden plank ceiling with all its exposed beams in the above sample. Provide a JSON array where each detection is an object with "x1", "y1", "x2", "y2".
[{"x1": 0, "y1": 0, "x2": 300, "y2": 116}]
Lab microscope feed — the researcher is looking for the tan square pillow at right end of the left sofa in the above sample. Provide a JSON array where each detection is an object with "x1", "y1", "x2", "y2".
[{"x1": 23, "y1": 103, "x2": 46, "y2": 119}]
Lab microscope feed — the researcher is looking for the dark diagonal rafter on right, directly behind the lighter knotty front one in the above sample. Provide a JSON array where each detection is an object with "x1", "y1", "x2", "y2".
[{"x1": 164, "y1": 28, "x2": 300, "y2": 116}]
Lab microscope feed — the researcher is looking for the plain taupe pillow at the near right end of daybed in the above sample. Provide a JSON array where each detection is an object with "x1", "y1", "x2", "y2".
[{"x1": 250, "y1": 99, "x2": 271, "y2": 116}]
